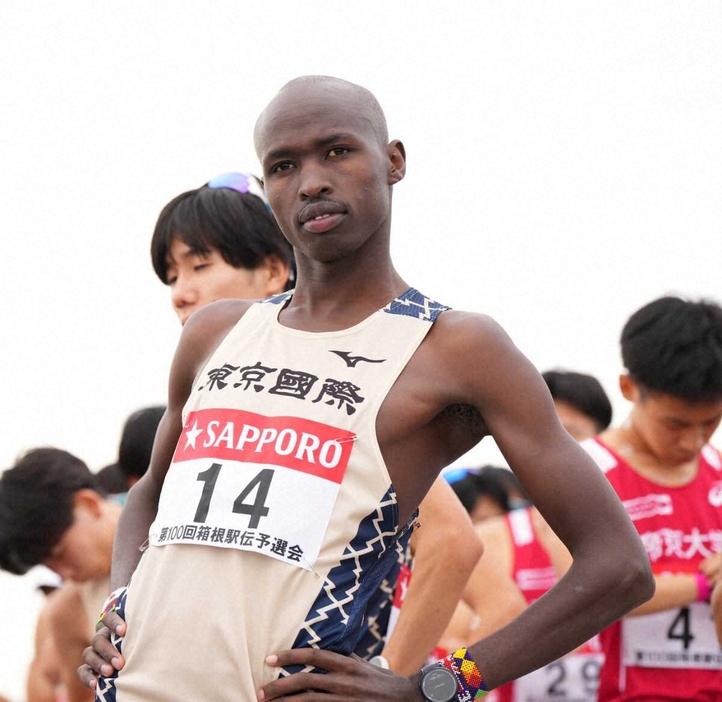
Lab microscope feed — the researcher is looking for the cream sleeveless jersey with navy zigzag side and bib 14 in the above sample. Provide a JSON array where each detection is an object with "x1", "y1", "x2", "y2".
[{"x1": 102, "y1": 289, "x2": 445, "y2": 702}]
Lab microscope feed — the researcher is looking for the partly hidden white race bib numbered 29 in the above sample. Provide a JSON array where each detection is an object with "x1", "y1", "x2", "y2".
[{"x1": 514, "y1": 653, "x2": 604, "y2": 702}]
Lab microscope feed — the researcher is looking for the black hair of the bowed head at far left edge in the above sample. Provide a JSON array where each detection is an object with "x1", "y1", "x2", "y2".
[{"x1": 0, "y1": 448, "x2": 98, "y2": 575}]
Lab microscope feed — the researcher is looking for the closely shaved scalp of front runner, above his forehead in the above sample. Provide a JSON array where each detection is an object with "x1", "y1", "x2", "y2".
[{"x1": 253, "y1": 76, "x2": 389, "y2": 150}]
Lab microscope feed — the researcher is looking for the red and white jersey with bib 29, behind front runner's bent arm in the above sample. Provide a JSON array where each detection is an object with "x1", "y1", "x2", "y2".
[{"x1": 490, "y1": 509, "x2": 603, "y2": 702}]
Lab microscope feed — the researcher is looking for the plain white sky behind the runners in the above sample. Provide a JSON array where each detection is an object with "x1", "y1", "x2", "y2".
[{"x1": 0, "y1": 0, "x2": 722, "y2": 700}]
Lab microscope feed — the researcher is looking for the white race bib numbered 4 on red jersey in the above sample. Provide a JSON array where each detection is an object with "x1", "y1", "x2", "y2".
[{"x1": 622, "y1": 602, "x2": 722, "y2": 670}]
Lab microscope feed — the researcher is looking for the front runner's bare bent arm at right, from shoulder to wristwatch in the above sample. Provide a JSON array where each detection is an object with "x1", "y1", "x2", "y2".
[{"x1": 430, "y1": 313, "x2": 654, "y2": 687}]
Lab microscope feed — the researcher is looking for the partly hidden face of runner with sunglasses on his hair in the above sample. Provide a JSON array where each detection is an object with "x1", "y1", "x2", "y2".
[{"x1": 166, "y1": 239, "x2": 282, "y2": 324}]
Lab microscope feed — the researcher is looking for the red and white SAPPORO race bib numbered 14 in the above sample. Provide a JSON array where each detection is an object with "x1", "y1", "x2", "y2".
[{"x1": 149, "y1": 408, "x2": 355, "y2": 570}]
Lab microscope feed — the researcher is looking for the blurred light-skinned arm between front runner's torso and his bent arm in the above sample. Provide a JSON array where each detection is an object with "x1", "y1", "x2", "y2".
[{"x1": 383, "y1": 478, "x2": 483, "y2": 675}]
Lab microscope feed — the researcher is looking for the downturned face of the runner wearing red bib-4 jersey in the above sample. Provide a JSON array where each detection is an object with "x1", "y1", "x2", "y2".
[{"x1": 625, "y1": 385, "x2": 722, "y2": 466}]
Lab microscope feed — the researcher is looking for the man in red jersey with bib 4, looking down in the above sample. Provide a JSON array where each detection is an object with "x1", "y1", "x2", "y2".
[{"x1": 582, "y1": 296, "x2": 722, "y2": 702}]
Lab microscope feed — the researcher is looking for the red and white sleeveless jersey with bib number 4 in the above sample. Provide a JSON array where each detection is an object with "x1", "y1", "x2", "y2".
[{"x1": 582, "y1": 439, "x2": 722, "y2": 702}]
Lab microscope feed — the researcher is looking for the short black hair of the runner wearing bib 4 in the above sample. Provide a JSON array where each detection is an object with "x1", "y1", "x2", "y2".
[{"x1": 621, "y1": 296, "x2": 722, "y2": 402}]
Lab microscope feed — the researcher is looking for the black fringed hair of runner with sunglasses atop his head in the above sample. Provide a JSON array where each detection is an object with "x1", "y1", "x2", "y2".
[{"x1": 150, "y1": 181, "x2": 296, "y2": 289}]
